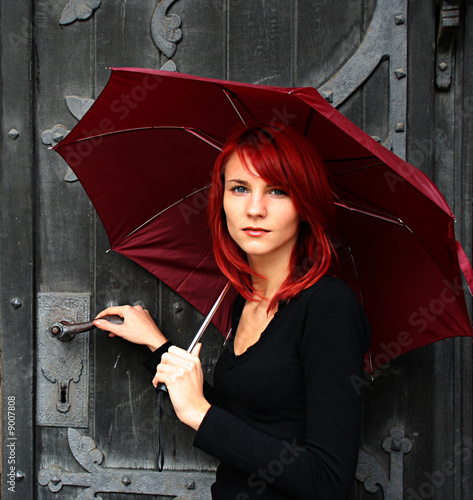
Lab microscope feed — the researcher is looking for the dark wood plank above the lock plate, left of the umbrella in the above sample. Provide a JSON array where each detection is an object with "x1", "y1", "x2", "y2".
[{"x1": 35, "y1": 3, "x2": 93, "y2": 293}]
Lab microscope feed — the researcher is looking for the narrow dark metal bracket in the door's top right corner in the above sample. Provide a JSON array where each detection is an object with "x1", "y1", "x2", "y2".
[{"x1": 435, "y1": 0, "x2": 464, "y2": 90}]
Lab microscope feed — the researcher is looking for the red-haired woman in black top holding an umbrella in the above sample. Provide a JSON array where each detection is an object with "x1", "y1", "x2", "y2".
[{"x1": 96, "y1": 125, "x2": 370, "y2": 500}]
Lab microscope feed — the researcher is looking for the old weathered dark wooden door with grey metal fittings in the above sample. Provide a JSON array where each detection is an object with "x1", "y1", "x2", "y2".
[{"x1": 0, "y1": 0, "x2": 473, "y2": 500}]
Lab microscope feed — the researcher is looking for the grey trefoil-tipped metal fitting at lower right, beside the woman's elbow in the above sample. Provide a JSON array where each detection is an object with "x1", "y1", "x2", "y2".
[{"x1": 356, "y1": 425, "x2": 412, "y2": 500}]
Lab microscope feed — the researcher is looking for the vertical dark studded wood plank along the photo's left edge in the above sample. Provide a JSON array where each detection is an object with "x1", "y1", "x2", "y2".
[{"x1": 0, "y1": 2, "x2": 36, "y2": 500}]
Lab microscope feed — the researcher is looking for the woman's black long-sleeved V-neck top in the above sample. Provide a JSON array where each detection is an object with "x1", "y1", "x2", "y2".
[{"x1": 143, "y1": 277, "x2": 370, "y2": 500}]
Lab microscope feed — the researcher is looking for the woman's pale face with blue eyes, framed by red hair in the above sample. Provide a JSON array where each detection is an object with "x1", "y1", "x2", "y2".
[{"x1": 223, "y1": 153, "x2": 300, "y2": 265}]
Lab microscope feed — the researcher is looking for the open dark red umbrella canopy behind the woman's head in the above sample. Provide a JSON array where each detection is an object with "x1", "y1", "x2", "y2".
[{"x1": 55, "y1": 68, "x2": 473, "y2": 368}]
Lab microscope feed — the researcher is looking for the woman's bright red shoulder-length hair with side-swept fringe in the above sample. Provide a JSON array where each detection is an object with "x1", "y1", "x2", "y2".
[{"x1": 208, "y1": 125, "x2": 335, "y2": 310}]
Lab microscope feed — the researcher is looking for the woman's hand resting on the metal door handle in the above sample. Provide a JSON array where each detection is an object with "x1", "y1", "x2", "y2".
[{"x1": 94, "y1": 306, "x2": 167, "y2": 351}]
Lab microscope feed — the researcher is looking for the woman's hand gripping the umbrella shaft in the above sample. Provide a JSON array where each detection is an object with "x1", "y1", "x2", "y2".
[{"x1": 153, "y1": 344, "x2": 210, "y2": 430}]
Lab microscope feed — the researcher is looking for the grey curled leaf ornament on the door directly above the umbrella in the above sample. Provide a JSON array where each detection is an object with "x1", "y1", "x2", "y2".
[{"x1": 151, "y1": 0, "x2": 182, "y2": 59}]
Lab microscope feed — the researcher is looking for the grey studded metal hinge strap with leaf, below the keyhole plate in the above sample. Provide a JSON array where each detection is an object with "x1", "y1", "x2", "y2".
[{"x1": 38, "y1": 427, "x2": 215, "y2": 500}]
